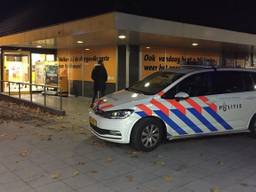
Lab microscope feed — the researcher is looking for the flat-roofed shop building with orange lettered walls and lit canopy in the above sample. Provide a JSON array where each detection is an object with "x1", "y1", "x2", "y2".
[{"x1": 0, "y1": 12, "x2": 256, "y2": 97}]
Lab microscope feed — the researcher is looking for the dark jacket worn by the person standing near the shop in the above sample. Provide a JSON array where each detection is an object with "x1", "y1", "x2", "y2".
[{"x1": 91, "y1": 64, "x2": 108, "y2": 90}]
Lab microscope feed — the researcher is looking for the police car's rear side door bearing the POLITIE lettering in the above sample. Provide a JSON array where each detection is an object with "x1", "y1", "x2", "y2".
[{"x1": 214, "y1": 70, "x2": 250, "y2": 130}]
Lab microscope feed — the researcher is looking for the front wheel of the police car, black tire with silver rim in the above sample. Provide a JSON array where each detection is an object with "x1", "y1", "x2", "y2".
[{"x1": 131, "y1": 118, "x2": 164, "y2": 152}]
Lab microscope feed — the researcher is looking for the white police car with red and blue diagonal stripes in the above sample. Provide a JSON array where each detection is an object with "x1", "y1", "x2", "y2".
[{"x1": 89, "y1": 67, "x2": 256, "y2": 151}]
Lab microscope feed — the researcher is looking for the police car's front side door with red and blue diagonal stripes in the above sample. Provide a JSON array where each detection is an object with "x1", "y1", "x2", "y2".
[{"x1": 160, "y1": 71, "x2": 222, "y2": 136}]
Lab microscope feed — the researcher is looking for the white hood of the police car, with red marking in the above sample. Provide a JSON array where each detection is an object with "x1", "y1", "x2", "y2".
[{"x1": 98, "y1": 90, "x2": 149, "y2": 111}]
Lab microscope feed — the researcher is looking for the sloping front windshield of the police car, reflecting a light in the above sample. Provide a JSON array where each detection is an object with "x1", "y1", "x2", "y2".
[{"x1": 128, "y1": 72, "x2": 184, "y2": 95}]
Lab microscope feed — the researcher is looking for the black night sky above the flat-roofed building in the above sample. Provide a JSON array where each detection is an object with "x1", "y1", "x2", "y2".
[{"x1": 0, "y1": 0, "x2": 256, "y2": 35}]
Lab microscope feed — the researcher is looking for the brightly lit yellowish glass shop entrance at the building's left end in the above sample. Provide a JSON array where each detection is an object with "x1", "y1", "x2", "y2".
[{"x1": 3, "y1": 51, "x2": 58, "y2": 93}]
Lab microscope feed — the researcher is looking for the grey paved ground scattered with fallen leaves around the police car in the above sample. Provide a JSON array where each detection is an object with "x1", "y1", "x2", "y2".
[{"x1": 0, "y1": 97, "x2": 256, "y2": 192}]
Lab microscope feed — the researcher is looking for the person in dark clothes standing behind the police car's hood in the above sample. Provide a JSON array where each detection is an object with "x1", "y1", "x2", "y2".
[{"x1": 91, "y1": 60, "x2": 108, "y2": 107}]
